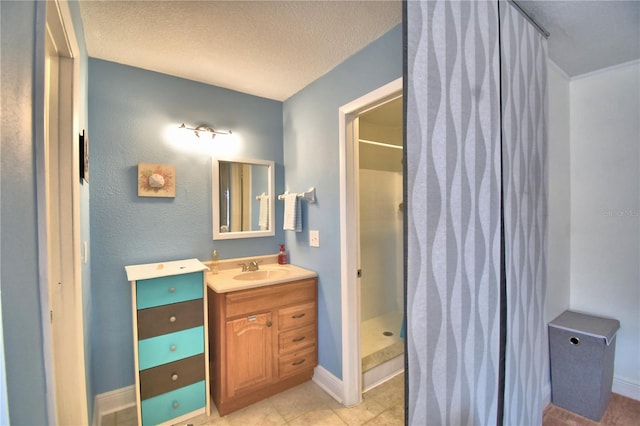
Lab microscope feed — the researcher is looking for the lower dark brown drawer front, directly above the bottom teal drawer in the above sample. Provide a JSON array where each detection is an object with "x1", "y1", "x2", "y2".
[{"x1": 140, "y1": 354, "x2": 205, "y2": 399}]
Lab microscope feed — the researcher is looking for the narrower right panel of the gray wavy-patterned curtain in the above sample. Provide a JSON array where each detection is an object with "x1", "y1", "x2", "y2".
[{"x1": 500, "y1": 2, "x2": 549, "y2": 425}]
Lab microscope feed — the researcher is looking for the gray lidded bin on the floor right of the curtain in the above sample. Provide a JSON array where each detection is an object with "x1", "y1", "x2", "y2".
[{"x1": 549, "y1": 311, "x2": 620, "y2": 422}]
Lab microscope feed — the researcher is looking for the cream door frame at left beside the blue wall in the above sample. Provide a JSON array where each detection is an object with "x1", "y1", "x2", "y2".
[{"x1": 34, "y1": 0, "x2": 89, "y2": 424}]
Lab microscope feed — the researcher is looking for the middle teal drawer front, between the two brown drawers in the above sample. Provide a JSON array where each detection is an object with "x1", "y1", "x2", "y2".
[{"x1": 138, "y1": 326, "x2": 204, "y2": 370}]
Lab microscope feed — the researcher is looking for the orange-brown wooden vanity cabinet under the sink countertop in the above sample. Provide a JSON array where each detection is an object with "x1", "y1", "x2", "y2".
[{"x1": 208, "y1": 277, "x2": 318, "y2": 416}]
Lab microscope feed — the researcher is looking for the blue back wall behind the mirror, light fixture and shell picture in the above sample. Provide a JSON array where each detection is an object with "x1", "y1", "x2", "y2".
[{"x1": 89, "y1": 59, "x2": 284, "y2": 394}]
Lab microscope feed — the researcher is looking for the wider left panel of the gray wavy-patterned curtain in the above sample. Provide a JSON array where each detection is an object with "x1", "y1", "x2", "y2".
[{"x1": 406, "y1": 1, "x2": 500, "y2": 425}]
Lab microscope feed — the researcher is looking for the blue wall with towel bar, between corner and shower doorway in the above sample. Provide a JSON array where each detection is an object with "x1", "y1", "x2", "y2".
[{"x1": 283, "y1": 25, "x2": 403, "y2": 378}]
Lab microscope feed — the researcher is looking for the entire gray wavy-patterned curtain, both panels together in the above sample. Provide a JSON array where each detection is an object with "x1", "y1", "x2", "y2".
[{"x1": 405, "y1": 0, "x2": 548, "y2": 425}]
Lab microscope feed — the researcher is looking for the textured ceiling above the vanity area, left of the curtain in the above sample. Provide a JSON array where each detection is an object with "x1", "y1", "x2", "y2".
[{"x1": 80, "y1": 0, "x2": 402, "y2": 100}]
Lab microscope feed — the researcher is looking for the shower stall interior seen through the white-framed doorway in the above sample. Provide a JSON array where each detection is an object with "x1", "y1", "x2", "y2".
[{"x1": 359, "y1": 98, "x2": 404, "y2": 390}]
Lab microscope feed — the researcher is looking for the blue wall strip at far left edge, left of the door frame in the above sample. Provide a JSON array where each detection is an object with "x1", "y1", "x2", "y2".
[{"x1": 0, "y1": 1, "x2": 47, "y2": 425}]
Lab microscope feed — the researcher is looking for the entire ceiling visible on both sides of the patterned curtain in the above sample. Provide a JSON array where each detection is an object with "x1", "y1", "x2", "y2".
[{"x1": 80, "y1": 0, "x2": 640, "y2": 100}]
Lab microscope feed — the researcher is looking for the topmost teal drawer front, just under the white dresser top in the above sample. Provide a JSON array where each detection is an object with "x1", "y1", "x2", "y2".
[{"x1": 136, "y1": 272, "x2": 204, "y2": 309}]
